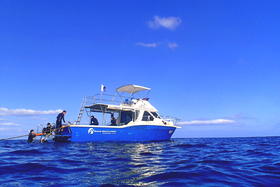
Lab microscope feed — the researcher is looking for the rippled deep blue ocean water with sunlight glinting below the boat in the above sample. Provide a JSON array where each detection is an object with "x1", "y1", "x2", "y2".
[{"x1": 0, "y1": 137, "x2": 280, "y2": 186}]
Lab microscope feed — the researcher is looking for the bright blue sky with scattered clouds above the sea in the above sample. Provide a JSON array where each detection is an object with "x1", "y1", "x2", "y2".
[{"x1": 0, "y1": 0, "x2": 280, "y2": 138}]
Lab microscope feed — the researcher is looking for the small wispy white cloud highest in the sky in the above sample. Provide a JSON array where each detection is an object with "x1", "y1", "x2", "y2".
[{"x1": 149, "y1": 16, "x2": 182, "y2": 30}]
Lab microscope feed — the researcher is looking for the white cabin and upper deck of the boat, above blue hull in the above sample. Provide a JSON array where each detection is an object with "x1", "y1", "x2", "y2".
[{"x1": 78, "y1": 85, "x2": 177, "y2": 126}]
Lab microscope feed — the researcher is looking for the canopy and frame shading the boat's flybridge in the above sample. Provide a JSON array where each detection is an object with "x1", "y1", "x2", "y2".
[{"x1": 117, "y1": 84, "x2": 151, "y2": 99}]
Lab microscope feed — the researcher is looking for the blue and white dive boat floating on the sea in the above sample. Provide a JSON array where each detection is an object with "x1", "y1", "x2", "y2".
[{"x1": 54, "y1": 84, "x2": 180, "y2": 142}]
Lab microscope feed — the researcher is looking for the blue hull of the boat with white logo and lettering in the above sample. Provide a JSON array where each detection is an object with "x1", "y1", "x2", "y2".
[{"x1": 55, "y1": 125, "x2": 176, "y2": 142}]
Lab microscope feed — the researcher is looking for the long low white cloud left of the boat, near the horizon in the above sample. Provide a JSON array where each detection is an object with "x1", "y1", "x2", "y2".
[{"x1": 0, "y1": 108, "x2": 62, "y2": 116}]
